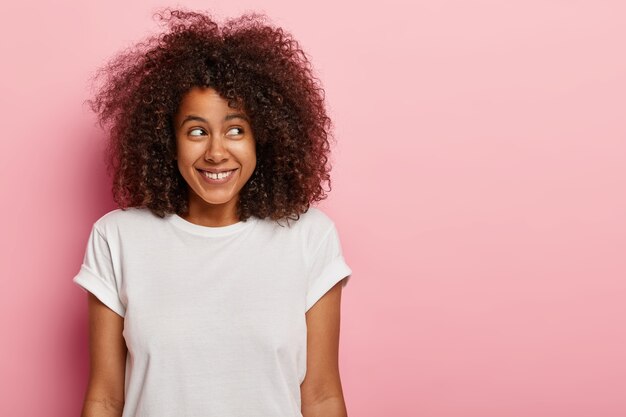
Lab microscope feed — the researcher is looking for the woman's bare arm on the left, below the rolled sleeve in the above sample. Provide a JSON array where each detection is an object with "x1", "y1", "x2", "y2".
[{"x1": 81, "y1": 293, "x2": 127, "y2": 417}]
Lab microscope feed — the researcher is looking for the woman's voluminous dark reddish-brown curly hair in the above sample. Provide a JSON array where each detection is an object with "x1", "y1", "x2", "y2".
[{"x1": 87, "y1": 8, "x2": 333, "y2": 221}]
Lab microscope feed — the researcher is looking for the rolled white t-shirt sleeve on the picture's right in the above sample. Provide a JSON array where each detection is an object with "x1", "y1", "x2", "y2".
[{"x1": 305, "y1": 224, "x2": 352, "y2": 311}]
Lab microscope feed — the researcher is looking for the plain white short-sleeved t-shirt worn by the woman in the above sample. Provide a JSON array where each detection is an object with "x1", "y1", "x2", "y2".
[{"x1": 73, "y1": 207, "x2": 352, "y2": 417}]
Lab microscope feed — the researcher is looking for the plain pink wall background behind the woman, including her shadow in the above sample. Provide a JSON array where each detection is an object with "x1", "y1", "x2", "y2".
[{"x1": 0, "y1": 0, "x2": 626, "y2": 417}]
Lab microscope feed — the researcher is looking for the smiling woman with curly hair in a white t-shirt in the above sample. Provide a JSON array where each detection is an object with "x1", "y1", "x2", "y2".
[{"x1": 74, "y1": 9, "x2": 351, "y2": 417}]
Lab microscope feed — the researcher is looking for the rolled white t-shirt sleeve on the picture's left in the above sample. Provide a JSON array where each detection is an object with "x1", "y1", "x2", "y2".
[{"x1": 73, "y1": 224, "x2": 126, "y2": 317}]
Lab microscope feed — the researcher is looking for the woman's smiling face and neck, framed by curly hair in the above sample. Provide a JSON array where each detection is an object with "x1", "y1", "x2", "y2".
[{"x1": 174, "y1": 87, "x2": 256, "y2": 216}]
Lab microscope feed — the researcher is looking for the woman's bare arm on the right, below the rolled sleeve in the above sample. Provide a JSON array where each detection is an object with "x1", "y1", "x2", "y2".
[{"x1": 300, "y1": 281, "x2": 348, "y2": 417}]
